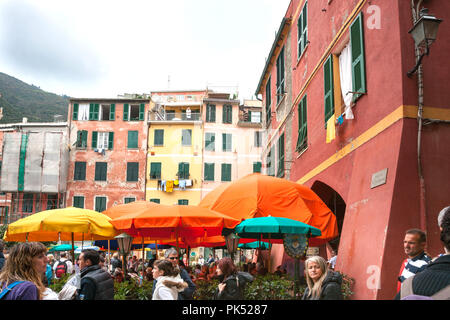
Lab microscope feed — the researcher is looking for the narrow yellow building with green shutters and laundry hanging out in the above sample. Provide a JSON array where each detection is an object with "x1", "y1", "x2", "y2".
[{"x1": 146, "y1": 91, "x2": 205, "y2": 205}]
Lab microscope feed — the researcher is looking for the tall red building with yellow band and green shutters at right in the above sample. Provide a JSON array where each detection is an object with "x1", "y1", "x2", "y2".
[{"x1": 256, "y1": 0, "x2": 450, "y2": 299}]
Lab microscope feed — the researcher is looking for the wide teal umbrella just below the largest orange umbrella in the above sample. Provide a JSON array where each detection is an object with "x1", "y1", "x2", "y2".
[{"x1": 234, "y1": 216, "x2": 322, "y2": 239}]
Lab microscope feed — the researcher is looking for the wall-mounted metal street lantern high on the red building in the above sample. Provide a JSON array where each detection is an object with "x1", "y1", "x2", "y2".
[{"x1": 408, "y1": 8, "x2": 442, "y2": 77}]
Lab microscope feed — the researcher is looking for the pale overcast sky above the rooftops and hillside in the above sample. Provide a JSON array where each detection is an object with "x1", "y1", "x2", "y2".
[{"x1": 0, "y1": 0, "x2": 289, "y2": 99}]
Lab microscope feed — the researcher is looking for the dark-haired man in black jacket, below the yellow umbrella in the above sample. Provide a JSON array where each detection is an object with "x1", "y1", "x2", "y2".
[{"x1": 77, "y1": 249, "x2": 114, "y2": 300}]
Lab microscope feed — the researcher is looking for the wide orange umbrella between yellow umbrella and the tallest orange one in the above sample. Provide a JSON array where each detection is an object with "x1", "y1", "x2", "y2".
[{"x1": 105, "y1": 204, "x2": 240, "y2": 242}]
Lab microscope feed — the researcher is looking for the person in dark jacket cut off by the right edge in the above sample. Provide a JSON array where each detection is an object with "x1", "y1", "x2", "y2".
[{"x1": 395, "y1": 207, "x2": 450, "y2": 300}]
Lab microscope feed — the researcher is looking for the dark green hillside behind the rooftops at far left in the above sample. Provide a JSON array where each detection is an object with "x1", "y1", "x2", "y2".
[{"x1": 0, "y1": 72, "x2": 69, "y2": 123}]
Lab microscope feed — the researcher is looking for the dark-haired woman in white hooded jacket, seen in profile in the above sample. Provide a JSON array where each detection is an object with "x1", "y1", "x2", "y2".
[{"x1": 152, "y1": 260, "x2": 188, "y2": 300}]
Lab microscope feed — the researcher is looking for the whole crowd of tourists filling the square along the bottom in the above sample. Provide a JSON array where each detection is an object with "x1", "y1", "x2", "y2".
[{"x1": 0, "y1": 207, "x2": 450, "y2": 300}]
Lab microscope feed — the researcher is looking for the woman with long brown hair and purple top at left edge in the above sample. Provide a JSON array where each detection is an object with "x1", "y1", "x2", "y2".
[{"x1": 0, "y1": 242, "x2": 48, "y2": 300}]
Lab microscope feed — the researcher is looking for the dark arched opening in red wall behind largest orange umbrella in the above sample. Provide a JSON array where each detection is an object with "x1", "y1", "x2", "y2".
[{"x1": 311, "y1": 181, "x2": 346, "y2": 252}]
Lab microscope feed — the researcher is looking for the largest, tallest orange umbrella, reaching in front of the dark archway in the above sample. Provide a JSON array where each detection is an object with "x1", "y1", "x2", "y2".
[{"x1": 199, "y1": 173, "x2": 338, "y2": 246}]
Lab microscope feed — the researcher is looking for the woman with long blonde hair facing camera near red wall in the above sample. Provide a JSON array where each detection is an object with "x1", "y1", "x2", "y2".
[{"x1": 302, "y1": 256, "x2": 343, "y2": 300}]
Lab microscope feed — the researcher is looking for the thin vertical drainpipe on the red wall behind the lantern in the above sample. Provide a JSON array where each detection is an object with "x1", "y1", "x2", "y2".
[{"x1": 411, "y1": 0, "x2": 427, "y2": 231}]
